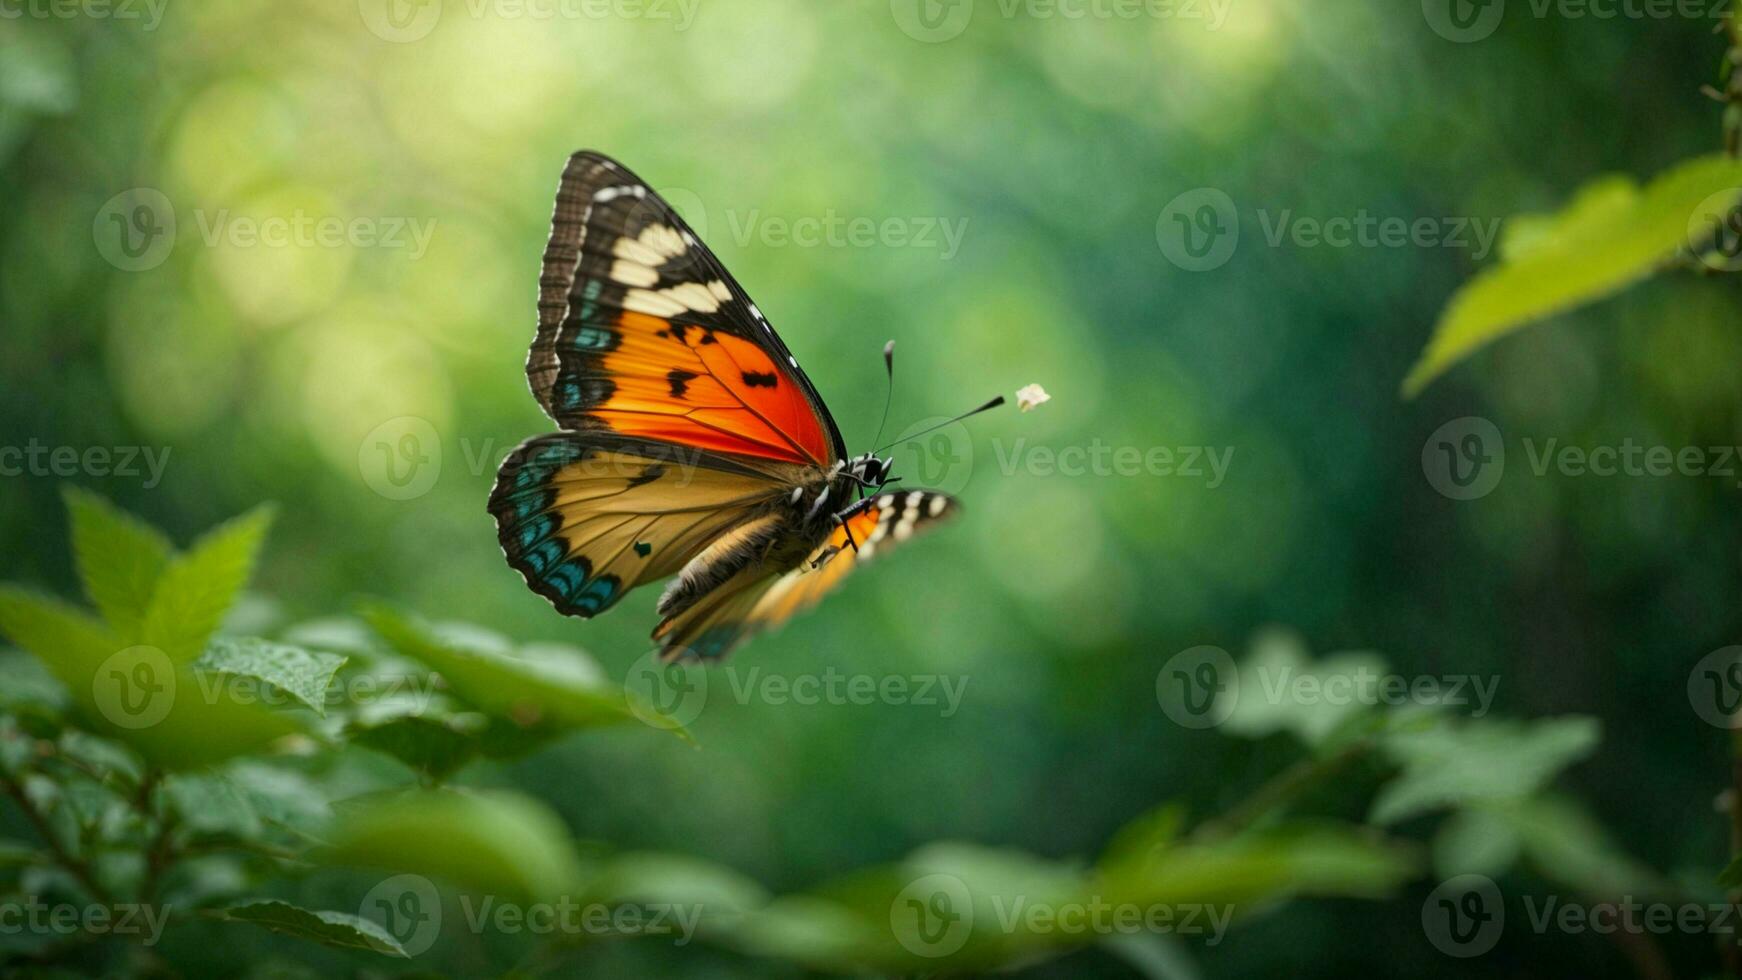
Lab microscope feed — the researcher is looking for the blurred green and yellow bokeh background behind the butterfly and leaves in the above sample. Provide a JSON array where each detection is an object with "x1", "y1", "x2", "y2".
[{"x1": 0, "y1": 0, "x2": 1742, "y2": 977}]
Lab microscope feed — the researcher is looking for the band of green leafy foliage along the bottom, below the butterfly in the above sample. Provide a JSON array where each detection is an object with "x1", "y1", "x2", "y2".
[{"x1": 0, "y1": 494, "x2": 1700, "y2": 973}]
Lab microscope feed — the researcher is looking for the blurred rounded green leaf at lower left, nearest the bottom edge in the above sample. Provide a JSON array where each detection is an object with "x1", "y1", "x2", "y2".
[{"x1": 317, "y1": 790, "x2": 582, "y2": 902}]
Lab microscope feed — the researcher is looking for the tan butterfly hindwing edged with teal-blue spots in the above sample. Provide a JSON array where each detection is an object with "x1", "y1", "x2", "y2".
[{"x1": 490, "y1": 432, "x2": 784, "y2": 616}]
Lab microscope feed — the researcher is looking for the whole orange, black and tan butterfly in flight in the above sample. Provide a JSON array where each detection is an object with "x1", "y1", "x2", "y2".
[{"x1": 490, "y1": 151, "x2": 1003, "y2": 660}]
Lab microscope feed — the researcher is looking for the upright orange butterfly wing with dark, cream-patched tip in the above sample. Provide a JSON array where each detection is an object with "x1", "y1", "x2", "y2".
[{"x1": 526, "y1": 151, "x2": 845, "y2": 467}]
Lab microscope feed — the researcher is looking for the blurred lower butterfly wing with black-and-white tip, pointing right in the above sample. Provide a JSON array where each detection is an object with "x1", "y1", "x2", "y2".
[{"x1": 653, "y1": 491, "x2": 958, "y2": 660}]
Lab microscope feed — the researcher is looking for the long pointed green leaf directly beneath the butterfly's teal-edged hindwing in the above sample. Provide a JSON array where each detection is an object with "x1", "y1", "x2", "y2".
[{"x1": 362, "y1": 606, "x2": 688, "y2": 752}]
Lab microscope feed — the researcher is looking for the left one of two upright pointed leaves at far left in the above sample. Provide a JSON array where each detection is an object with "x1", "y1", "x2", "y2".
[{"x1": 64, "y1": 487, "x2": 174, "y2": 639}]
